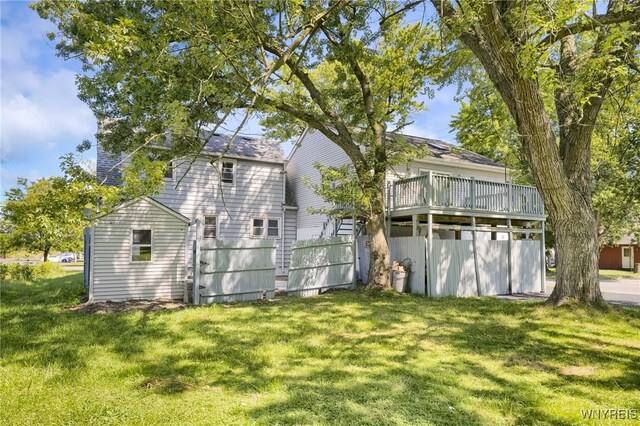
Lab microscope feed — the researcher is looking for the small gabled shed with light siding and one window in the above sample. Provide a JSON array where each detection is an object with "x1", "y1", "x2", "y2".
[{"x1": 89, "y1": 197, "x2": 189, "y2": 302}]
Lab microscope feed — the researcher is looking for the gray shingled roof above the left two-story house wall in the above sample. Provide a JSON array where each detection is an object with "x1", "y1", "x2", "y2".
[{"x1": 204, "y1": 133, "x2": 284, "y2": 163}]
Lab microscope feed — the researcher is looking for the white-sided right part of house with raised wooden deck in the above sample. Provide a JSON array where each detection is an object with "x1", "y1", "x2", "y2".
[{"x1": 287, "y1": 129, "x2": 545, "y2": 295}]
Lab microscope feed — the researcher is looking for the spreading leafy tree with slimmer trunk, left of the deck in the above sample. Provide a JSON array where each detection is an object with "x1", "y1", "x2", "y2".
[{"x1": 33, "y1": 0, "x2": 438, "y2": 288}]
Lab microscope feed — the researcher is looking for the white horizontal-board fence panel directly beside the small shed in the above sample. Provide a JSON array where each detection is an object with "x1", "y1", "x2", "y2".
[{"x1": 193, "y1": 238, "x2": 276, "y2": 305}]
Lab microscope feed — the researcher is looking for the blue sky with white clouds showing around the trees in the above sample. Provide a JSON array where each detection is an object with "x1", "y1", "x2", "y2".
[{"x1": 0, "y1": 1, "x2": 458, "y2": 193}]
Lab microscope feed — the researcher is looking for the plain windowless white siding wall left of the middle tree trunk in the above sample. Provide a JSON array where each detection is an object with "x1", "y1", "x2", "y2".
[{"x1": 287, "y1": 129, "x2": 351, "y2": 239}]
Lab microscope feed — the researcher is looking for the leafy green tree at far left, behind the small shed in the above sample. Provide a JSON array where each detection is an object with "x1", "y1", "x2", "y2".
[{"x1": 2, "y1": 154, "x2": 115, "y2": 261}]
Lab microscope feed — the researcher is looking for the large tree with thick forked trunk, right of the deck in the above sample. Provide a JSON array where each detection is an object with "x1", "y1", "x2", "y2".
[{"x1": 431, "y1": 0, "x2": 640, "y2": 305}]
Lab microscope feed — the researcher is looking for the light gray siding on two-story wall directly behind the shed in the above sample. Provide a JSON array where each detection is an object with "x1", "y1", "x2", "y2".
[{"x1": 153, "y1": 158, "x2": 284, "y2": 266}]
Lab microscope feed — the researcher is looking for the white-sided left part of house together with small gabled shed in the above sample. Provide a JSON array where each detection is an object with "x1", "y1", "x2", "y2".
[{"x1": 86, "y1": 133, "x2": 297, "y2": 301}]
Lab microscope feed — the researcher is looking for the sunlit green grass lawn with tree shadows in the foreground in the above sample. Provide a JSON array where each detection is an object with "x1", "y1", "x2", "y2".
[{"x1": 0, "y1": 274, "x2": 640, "y2": 425}]
